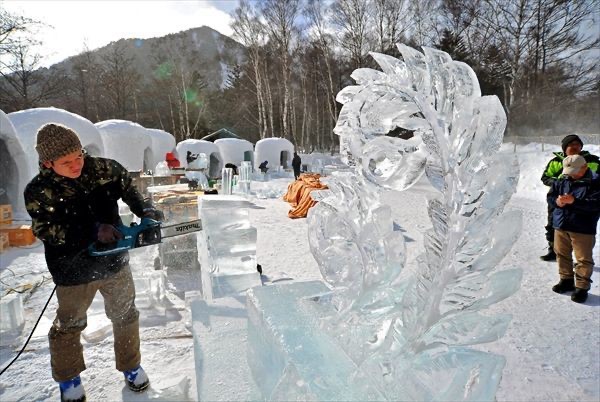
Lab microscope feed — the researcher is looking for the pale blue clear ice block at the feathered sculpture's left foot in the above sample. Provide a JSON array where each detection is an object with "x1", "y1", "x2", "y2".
[{"x1": 247, "y1": 281, "x2": 385, "y2": 401}]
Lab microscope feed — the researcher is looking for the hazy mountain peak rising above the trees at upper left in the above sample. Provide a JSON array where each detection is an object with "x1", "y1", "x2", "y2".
[{"x1": 50, "y1": 26, "x2": 245, "y2": 89}]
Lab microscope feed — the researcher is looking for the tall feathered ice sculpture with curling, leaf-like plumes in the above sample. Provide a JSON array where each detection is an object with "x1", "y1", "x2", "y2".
[{"x1": 255, "y1": 45, "x2": 521, "y2": 401}]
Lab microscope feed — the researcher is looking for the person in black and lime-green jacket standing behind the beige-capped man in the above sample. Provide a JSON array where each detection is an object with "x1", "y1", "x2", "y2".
[{"x1": 540, "y1": 134, "x2": 600, "y2": 261}]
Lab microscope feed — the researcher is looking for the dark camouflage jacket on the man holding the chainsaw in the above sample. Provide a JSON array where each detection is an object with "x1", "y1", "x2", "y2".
[{"x1": 24, "y1": 156, "x2": 144, "y2": 286}]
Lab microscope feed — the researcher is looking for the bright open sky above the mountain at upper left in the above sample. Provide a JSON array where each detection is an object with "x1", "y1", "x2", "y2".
[{"x1": 0, "y1": 0, "x2": 238, "y2": 67}]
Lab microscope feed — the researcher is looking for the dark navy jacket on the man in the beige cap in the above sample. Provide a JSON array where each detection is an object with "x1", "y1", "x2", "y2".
[{"x1": 548, "y1": 169, "x2": 600, "y2": 234}]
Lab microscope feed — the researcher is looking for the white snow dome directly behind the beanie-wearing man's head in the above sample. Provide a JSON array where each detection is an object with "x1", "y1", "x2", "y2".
[{"x1": 8, "y1": 107, "x2": 105, "y2": 179}]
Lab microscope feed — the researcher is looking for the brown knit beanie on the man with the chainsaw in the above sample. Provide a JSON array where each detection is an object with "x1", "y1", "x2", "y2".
[{"x1": 35, "y1": 123, "x2": 82, "y2": 163}]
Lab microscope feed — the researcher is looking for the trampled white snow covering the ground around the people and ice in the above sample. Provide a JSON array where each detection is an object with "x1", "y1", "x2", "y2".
[{"x1": 0, "y1": 144, "x2": 600, "y2": 401}]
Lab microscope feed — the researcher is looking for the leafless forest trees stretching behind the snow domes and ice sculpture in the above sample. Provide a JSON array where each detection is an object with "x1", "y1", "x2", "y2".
[{"x1": 0, "y1": 0, "x2": 600, "y2": 151}]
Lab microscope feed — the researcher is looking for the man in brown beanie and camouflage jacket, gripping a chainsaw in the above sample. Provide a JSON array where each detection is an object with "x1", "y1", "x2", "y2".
[{"x1": 24, "y1": 123, "x2": 160, "y2": 401}]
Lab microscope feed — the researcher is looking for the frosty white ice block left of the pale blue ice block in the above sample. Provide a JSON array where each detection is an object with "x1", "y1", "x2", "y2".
[{"x1": 186, "y1": 293, "x2": 261, "y2": 401}]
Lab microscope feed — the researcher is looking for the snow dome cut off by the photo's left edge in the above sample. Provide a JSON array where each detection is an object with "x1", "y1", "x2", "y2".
[{"x1": 0, "y1": 110, "x2": 30, "y2": 216}]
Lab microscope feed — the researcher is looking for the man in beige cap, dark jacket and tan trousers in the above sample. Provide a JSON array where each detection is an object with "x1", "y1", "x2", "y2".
[{"x1": 548, "y1": 155, "x2": 600, "y2": 303}]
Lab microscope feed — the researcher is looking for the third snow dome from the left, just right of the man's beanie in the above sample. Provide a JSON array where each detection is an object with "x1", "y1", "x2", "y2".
[{"x1": 95, "y1": 120, "x2": 156, "y2": 172}]
